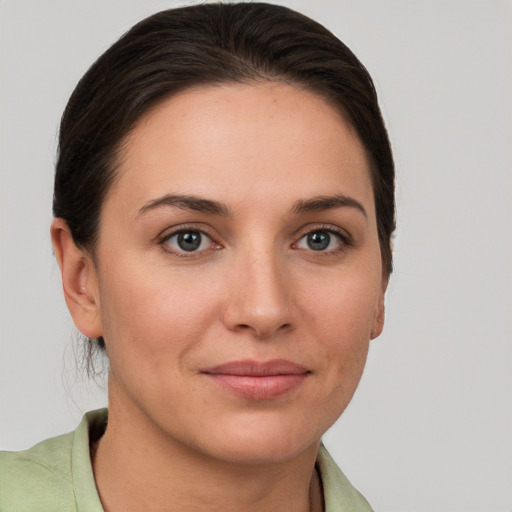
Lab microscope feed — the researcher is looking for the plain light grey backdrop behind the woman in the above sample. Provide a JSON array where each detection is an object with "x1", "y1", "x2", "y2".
[{"x1": 0, "y1": 0, "x2": 512, "y2": 512}]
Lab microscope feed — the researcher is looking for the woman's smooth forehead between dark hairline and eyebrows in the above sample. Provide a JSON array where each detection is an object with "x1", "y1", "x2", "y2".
[{"x1": 113, "y1": 82, "x2": 373, "y2": 216}]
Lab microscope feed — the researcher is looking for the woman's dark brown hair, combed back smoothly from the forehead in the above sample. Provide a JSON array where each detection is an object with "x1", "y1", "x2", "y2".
[{"x1": 53, "y1": 3, "x2": 395, "y2": 352}]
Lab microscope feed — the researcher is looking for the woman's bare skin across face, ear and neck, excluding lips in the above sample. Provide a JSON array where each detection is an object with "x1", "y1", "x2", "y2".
[{"x1": 52, "y1": 83, "x2": 387, "y2": 511}]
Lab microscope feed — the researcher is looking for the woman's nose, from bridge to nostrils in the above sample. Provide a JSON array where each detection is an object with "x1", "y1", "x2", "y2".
[{"x1": 223, "y1": 250, "x2": 293, "y2": 339}]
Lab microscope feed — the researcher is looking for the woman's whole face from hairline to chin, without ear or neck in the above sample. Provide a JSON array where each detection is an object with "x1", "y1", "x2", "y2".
[{"x1": 90, "y1": 83, "x2": 385, "y2": 462}]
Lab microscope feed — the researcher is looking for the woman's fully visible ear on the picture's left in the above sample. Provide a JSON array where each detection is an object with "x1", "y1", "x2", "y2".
[{"x1": 51, "y1": 218, "x2": 103, "y2": 338}]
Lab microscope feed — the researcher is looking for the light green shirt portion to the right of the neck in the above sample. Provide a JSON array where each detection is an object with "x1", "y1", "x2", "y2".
[{"x1": 316, "y1": 445, "x2": 373, "y2": 512}]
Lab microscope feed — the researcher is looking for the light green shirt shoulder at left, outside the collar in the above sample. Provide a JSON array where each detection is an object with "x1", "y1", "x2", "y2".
[{"x1": 0, "y1": 433, "x2": 74, "y2": 511}]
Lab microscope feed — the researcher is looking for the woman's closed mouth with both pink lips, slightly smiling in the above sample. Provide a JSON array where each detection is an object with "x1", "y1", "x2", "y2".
[{"x1": 201, "y1": 359, "x2": 311, "y2": 400}]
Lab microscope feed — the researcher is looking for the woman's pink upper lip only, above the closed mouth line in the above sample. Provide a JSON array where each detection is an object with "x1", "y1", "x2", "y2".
[{"x1": 202, "y1": 359, "x2": 309, "y2": 377}]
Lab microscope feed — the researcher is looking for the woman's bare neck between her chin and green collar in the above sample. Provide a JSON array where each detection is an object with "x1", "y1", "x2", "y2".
[{"x1": 92, "y1": 386, "x2": 323, "y2": 512}]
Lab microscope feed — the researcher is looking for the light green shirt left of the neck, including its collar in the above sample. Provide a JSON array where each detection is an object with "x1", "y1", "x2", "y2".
[{"x1": 0, "y1": 410, "x2": 106, "y2": 512}]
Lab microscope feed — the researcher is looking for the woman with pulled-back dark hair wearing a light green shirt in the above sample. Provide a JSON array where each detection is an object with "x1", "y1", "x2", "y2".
[{"x1": 0, "y1": 4, "x2": 394, "y2": 512}]
